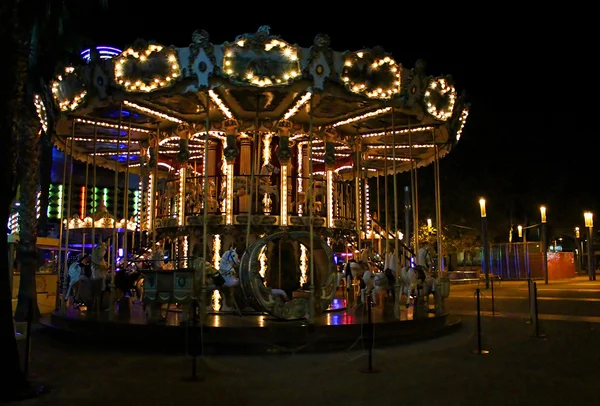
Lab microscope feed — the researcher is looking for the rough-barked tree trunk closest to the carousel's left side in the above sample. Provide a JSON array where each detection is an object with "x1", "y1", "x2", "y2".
[{"x1": 14, "y1": 0, "x2": 107, "y2": 321}]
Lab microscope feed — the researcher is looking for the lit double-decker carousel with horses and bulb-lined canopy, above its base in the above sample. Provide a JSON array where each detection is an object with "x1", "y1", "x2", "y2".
[{"x1": 44, "y1": 26, "x2": 468, "y2": 346}]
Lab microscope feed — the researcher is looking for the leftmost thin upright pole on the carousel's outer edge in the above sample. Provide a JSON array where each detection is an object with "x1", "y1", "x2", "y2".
[{"x1": 57, "y1": 120, "x2": 76, "y2": 315}]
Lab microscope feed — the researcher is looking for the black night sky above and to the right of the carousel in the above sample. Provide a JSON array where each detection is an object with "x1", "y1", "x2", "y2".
[{"x1": 77, "y1": 1, "x2": 600, "y2": 239}]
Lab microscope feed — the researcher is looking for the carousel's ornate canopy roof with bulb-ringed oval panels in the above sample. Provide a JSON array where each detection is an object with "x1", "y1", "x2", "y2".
[{"x1": 44, "y1": 27, "x2": 469, "y2": 178}]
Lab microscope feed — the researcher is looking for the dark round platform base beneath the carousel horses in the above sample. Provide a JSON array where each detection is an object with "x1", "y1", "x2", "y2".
[{"x1": 44, "y1": 301, "x2": 461, "y2": 354}]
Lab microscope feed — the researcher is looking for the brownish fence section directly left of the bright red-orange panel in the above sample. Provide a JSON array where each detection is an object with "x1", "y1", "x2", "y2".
[{"x1": 490, "y1": 242, "x2": 544, "y2": 280}]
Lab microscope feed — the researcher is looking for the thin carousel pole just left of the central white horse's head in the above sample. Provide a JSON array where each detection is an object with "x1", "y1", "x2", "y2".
[{"x1": 200, "y1": 89, "x2": 210, "y2": 318}]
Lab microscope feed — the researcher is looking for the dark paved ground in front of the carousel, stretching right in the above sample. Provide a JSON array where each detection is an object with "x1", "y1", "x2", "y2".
[{"x1": 8, "y1": 280, "x2": 600, "y2": 406}]
